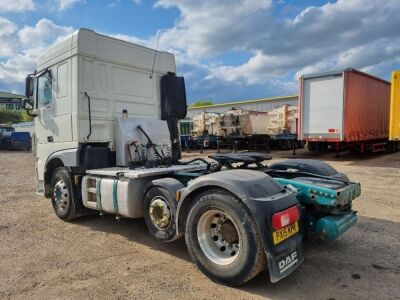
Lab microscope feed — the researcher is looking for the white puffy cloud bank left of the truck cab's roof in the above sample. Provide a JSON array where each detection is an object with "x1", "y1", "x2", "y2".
[{"x1": 0, "y1": 18, "x2": 73, "y2": 85}]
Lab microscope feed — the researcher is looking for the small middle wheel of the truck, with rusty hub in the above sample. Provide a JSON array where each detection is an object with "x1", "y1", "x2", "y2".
[{"x1": 144, "y1": 186, "x2": 177, "y2": 241}]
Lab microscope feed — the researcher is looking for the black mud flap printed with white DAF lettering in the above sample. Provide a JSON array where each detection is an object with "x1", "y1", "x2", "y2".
[{"x1": 267, "y1": 244, "x2": 304, "y2": 283}]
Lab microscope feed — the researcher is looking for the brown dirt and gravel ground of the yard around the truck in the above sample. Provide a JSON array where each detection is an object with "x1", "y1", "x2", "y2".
[{"x1": 0, "y1": 151, "x2": 400, "y2": 299}]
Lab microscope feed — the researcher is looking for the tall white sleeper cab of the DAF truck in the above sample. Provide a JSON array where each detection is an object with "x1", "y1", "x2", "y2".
[{"x1": 25, "y1": 29, "x2": 186, "y2": 196}]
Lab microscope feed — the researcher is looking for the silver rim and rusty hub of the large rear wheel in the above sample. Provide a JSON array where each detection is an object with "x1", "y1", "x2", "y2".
[{"x1": 197, "y1": 210, "x2": 240, "y2": 265}]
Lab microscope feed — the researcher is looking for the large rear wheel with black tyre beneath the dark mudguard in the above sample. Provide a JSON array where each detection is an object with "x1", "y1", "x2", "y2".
[{"x1": 185, "y1": 190, "x2": 266, "y2": 286}]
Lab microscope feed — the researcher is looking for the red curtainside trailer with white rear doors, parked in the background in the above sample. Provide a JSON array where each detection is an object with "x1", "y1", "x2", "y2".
[{"x1": 299, "y1": 69, "x2": 390, "y2": 154}]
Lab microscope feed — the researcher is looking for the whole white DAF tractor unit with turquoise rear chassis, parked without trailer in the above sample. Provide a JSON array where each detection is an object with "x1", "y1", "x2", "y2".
[{"x1": 23, "y1": 29, "x2": 361, "y2": 285}]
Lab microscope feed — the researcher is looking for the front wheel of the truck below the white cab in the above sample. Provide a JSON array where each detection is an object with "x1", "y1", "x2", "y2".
[{"x1": 51, "y1": 167, "x2": 83, "y2": 221}]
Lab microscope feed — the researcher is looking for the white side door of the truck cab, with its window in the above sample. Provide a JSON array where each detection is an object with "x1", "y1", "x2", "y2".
[{"x1": 35, "y1": 69, "x2": 54, "y2": 180}]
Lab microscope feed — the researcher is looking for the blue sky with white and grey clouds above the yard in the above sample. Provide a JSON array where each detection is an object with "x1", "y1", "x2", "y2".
[{"x1": 0, "y1": 0, "x2": 400, "y2": 103}]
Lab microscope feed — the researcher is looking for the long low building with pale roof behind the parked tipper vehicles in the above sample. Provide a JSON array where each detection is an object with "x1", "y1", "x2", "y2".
[{"x1": 186, "y1": 95, "x2": 298, "y2": 119}]
